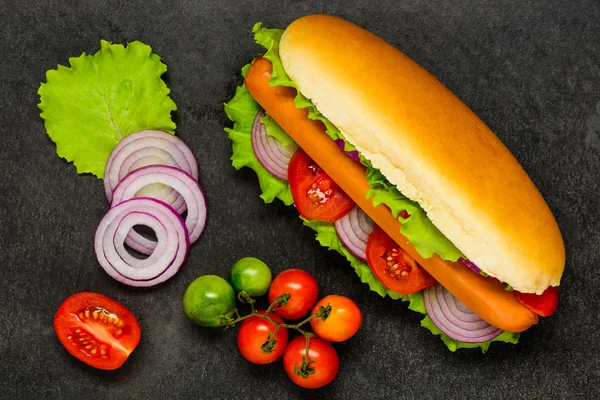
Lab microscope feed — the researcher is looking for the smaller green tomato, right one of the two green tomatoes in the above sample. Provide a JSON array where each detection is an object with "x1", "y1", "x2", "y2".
[{"x1": 231, "y1": 257, "x2": 271, "y2": 297}]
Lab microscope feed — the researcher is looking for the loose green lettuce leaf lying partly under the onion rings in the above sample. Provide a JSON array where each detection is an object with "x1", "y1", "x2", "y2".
[{"x1": 38, "y1": 40, "x2": 177, "y2": 178}]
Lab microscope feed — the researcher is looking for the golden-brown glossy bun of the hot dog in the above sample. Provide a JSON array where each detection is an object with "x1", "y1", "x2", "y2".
[{"x1": 279, "y1": 15, "x2": 565, "y2": 294}]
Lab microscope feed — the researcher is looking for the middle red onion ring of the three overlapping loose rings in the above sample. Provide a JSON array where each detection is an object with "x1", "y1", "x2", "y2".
[{"x1": 112, "y1": 165, "x2": 206, "y2": 250}]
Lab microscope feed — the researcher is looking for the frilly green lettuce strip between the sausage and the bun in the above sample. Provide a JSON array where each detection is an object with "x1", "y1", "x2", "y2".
[{"x1": 252, "y1": 22, "x2": 462, "y2": 261}]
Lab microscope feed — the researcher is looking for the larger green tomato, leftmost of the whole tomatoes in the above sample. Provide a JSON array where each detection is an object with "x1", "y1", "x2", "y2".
[{"x1": 183, "y1": 275, "x2": 236, "y2": 328}]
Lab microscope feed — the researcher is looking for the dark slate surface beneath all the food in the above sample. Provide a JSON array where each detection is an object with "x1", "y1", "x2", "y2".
[{"x1": 0, "y1": 0, "x2": 600, "y2": 399}]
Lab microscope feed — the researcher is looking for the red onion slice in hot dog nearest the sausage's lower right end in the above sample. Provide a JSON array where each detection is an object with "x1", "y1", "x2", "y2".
[{"x1": 423, "y1": 284, "x2": 502, "y2": 343}]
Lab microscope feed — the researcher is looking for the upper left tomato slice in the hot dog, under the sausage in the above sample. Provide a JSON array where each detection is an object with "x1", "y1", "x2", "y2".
[{"x1": 288, "y1": 150, "x2": 354, "y2": 222}]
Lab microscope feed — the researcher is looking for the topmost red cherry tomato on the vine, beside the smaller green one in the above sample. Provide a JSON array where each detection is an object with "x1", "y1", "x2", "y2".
[{"x1": 269, "y1": 269, "x2": 319, "y2": 319}]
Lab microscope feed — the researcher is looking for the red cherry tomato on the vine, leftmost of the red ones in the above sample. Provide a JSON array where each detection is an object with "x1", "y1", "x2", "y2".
[{"x1": 238, "y1": 311, "x2": 288, "y2": 364}]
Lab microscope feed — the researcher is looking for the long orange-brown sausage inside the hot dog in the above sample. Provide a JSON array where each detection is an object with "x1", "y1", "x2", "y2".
[{"x1": 245, "y1": 57, "x2": 538, "y2": 332}]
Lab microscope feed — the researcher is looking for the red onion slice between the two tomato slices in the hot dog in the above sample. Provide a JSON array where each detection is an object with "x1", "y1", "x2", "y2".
[{"x1": 334, "y1": 206, "x2": 375, "y2": 261}]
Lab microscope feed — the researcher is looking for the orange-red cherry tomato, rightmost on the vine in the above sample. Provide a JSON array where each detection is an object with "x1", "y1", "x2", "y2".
[{"x1": 310, "y1": 295, "x2": 362, "y2": 342}]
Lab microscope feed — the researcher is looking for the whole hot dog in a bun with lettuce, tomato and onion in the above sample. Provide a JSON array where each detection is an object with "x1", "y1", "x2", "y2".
[{"x1": 225, "y1": 15, "x2": 564, "y2": 351}]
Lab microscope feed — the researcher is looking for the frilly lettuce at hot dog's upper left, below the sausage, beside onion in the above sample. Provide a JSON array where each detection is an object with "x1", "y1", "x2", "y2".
[{"x1": 224, "y1": 64, "x2": 294, "y2": 205}]
